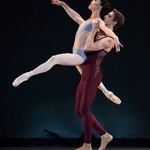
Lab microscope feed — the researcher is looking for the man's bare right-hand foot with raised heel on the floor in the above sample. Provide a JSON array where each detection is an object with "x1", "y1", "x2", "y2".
[{"x1": 98, "y1": 133, "x2": 113, "y2": 150}]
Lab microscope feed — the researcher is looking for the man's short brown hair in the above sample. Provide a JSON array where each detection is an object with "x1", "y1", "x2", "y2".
[{"x1": 112, "y1": 9, "x2": 125, "y2": 30}]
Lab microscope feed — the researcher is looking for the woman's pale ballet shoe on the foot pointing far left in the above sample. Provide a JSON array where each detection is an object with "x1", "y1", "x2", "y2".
[{"x1": 12, "y1": 72, "x2": 31, "y2": 87}]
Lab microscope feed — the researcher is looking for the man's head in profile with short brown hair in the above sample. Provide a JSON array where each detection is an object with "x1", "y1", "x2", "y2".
[{"x1": 104, "y1": 9, "x2": 125, "y2": 30}]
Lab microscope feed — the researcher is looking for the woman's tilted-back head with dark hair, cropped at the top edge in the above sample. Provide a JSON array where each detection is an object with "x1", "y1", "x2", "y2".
[{"x1": 89, "y1": 0, "x2": 110, "y2": 11}]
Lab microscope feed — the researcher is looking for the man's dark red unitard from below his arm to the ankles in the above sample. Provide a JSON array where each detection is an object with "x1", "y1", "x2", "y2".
[{"x1": 75, "y1": 50, "x2": 107, "y2": 143}]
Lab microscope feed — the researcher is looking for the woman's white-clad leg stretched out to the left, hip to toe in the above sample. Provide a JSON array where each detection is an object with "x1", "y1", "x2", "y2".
[{"x1": 12, "y1": 53, "x2": 84, "y2": 87}]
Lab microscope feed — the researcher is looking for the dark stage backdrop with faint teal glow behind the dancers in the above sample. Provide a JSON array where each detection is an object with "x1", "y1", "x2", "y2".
[{"x1": 0, "y1": 0, "x2": 150, "y2": 139}]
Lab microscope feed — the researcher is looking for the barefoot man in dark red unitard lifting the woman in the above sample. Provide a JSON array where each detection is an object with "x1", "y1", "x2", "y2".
[{"x1": 75, "y1": 9, "x2": 125, "y2": 150}]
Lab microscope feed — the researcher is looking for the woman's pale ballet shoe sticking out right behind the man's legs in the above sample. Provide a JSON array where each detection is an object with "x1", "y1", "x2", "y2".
[{"x1": 105, "y1": 91, "x2": 121, "y2": 105}]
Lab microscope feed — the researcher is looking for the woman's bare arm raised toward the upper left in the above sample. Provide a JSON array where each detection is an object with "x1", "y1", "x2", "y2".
[{"x1": 51, "y1": 0, "x2": 84, "y2": 25}]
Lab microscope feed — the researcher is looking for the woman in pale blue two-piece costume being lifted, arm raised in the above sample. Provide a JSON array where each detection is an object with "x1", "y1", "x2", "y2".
[{"x1": 13, "y1": 0, "x2": 121, "y2": 94}]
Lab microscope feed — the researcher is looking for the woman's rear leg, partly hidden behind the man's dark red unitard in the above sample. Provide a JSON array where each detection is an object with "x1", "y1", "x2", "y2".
[{"x1": 76, "y1": 66, "x2": 121, "y2": 105}]
